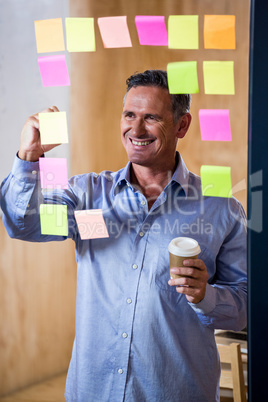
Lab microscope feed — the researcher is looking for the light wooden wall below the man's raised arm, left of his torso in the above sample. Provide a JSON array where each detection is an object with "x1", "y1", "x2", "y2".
[{"x1": 0, "y1": 220, "x2": 76, "y2": 396}]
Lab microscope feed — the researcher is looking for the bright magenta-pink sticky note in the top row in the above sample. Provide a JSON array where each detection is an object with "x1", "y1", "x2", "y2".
[{"x1": 135, "y1": 15, "x2": 168, "y2": 46}]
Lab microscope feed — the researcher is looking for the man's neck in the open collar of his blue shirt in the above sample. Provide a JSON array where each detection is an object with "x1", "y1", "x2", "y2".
[{"x1": 131, "y1": 160, "x2": 177, "y2": 209}]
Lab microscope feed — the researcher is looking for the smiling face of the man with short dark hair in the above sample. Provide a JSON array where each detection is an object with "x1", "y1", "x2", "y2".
[{"x1": 121, "y1": 86, "x2": 178, "y2": 168}]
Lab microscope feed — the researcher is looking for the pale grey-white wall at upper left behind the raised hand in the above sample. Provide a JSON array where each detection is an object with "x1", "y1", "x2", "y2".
[{"x1": 0, "y1": 0, "x2": 70, "y2": 182}]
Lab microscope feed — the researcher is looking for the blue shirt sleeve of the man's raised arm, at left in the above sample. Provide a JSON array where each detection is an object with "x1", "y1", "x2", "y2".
[{"x1": 0, "y1": 156, "x2": 77, "y2": 242}]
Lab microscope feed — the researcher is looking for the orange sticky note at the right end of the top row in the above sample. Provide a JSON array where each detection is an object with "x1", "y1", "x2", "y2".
[{"x1": 204, "y1": 15, "x2": 235, "y2": 49}]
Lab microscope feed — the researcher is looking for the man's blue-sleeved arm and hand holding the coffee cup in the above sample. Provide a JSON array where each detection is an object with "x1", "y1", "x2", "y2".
[{"x1": 169, "y1": 202, "x2": 247, "y2": 331}]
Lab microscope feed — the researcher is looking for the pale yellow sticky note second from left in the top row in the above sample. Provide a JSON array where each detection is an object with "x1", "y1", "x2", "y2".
[{"x1": 65, "y1": 18, "x2": 96, "y2": 52}]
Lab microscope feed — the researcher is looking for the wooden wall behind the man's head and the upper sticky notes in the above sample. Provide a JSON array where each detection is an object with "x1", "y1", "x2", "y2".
[{"x1": 70, "y1": 0, "x2": 249, "y2": 207}]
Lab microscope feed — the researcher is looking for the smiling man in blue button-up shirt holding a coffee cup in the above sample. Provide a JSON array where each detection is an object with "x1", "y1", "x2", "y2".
[{"x1": 1, "y1": 70, "x2": 247, "y2": 402}]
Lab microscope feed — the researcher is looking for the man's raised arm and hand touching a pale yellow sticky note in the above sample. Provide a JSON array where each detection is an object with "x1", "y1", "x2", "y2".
[{"x1": 0, "y1": 106, "x2": 76, "y2": 241}]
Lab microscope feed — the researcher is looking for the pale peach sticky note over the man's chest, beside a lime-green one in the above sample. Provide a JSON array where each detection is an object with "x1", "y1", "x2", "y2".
[{"x1": 74, "y1": 209, "x2": 109, "y2": 240}]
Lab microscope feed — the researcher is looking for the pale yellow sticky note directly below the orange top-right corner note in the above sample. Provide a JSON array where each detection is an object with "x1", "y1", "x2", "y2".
[{"x1": 203, "y1": 61, "x2": 235, "y2": 95}]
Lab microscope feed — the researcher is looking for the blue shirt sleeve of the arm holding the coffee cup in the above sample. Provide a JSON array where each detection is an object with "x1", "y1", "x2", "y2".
[{"x1": 189, "y1": 202, "x2": 247, "y2": 331}]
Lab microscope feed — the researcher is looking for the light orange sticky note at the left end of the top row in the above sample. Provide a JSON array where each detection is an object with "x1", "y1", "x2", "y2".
[{"x1": 34, "y1": 18, "x2": 65, "y2": 53}]
